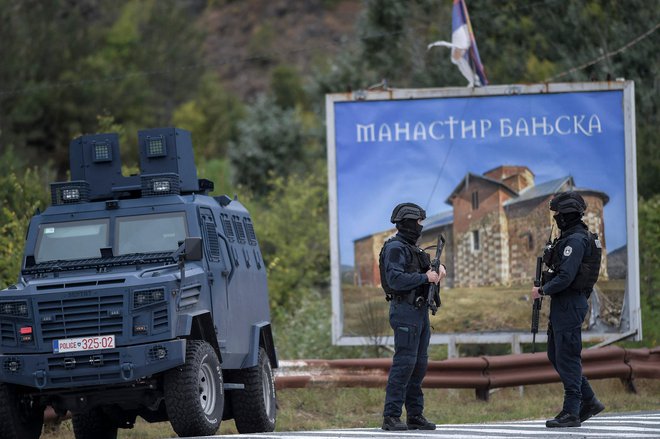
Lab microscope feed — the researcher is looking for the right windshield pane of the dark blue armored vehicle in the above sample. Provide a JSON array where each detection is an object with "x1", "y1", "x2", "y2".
[{"x1": 115, "y1": 212, "x2": 188, "y2": 256}]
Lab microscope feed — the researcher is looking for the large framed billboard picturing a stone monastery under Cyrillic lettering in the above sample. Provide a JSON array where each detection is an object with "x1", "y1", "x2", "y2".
[{"x1": 326, "y1": 81, "x2": 642, "y2": 345}]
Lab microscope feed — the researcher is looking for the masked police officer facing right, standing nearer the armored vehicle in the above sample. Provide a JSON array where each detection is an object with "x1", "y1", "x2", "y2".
[{"x1": 379, "y1": 203, "x2": 447, "y2": 430}]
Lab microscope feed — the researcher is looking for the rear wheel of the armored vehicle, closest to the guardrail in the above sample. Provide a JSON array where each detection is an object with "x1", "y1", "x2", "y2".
[{"x1": 231, "y1": 348, "x2": 277, "y2": 433}]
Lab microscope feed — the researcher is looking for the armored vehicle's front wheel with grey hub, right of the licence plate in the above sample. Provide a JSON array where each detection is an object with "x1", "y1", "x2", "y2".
[{"x1": 164, "y1": 340, "x2": 224, "y2": 436}]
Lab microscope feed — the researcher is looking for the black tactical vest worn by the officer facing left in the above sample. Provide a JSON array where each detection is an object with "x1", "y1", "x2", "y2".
[{"x1": 544, "y1": 230, "x2": 603, "y2": 297}]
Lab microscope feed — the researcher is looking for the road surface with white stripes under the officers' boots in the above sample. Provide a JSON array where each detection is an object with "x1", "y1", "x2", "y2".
[{"x1": 178, "y1": 410, "x2": 660, "y2": 439}]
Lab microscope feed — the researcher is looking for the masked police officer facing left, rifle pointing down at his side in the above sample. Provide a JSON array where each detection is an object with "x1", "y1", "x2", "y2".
[{"x1": 532, "y1": 192, "x2": 605, "y2": 428}]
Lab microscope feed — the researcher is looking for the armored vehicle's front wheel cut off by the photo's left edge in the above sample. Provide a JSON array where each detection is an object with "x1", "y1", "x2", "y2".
[{"x1": 0, "y1": 383, "x2": 44, "y2": 439}]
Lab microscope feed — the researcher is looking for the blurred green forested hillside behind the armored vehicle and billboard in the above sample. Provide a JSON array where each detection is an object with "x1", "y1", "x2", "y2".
[{"x1": 0, "y1": 0, "x2": 660, "y2": 358}]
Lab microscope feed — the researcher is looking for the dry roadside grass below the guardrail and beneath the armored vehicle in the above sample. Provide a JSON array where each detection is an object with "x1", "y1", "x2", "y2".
[{"x1": 42, "y1": 379, "x2": 660, "y2": 439}]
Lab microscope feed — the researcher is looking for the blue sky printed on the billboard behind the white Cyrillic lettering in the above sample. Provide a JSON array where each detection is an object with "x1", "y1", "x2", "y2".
[{"x1": 329, "y1": 90, "x2": 627, "y2": 265}]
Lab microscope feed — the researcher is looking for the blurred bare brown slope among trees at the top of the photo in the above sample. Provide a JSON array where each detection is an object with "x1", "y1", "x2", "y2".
[{"x1": 202, "y1": 0, "x2": 362, "y2": 98}]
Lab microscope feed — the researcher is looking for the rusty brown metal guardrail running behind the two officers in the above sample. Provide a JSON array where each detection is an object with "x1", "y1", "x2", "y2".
[{"x1": 275, "y1": 346, "x2": 660, "y2": 400}]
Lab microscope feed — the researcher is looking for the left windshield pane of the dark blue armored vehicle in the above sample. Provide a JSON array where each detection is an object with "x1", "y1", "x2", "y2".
[{"x1": 34, "y1": 219, "x2": 109, "y2": 264}]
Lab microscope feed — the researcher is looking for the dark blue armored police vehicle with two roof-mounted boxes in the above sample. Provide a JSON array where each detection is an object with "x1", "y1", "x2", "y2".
[{"x1": 0, "y1": 128, "x2": 277, "y2": 439}]
